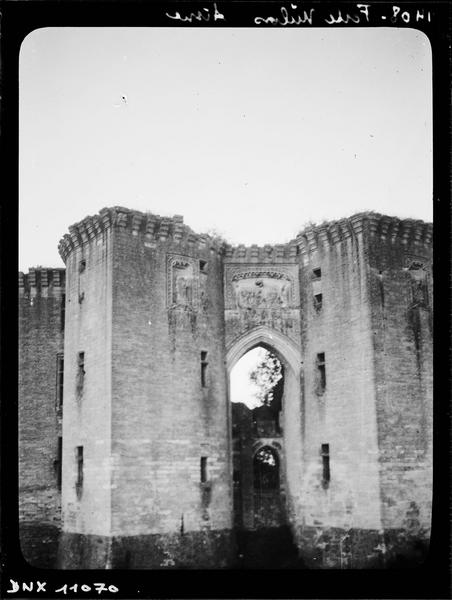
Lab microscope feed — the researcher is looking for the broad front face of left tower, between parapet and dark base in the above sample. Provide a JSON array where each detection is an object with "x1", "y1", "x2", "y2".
[{"x1": 108, "y1": 225, "x2": 231, "y2": 535}]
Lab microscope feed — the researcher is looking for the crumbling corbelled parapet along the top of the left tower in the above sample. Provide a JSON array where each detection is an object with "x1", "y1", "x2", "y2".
[{"x1": 58, "y1": 206, "x2": 228, "y2": 263}]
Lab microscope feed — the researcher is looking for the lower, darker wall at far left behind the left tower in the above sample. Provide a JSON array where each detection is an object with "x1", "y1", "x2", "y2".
[{"x1": 19, "y1": 268, "x2": 65, "y2": 567}]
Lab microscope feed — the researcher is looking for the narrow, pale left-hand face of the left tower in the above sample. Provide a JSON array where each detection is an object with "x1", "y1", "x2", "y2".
[{"x1": 59, "y1": 217, "x2": 113, "y2": 568}]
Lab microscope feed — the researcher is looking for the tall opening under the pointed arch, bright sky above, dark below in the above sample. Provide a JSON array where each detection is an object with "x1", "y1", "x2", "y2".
[{"x1": 231, "y1": 346, "x2": 300, "y2": 569}]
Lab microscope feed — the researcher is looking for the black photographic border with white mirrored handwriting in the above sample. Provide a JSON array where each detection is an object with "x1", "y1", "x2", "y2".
[{"x1": 0, "y1": 0, "x2": 452, "y2": 599}]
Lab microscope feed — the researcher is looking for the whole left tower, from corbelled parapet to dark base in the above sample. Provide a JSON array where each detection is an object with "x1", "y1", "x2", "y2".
[{"x1": 60, "y1": 207, "x2": 232, "y2": 568}]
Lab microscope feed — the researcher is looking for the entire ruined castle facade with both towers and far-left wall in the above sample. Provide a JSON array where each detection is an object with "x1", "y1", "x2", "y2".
[{"x1": 19, "y1": 207, "x2": 433, "y2": 569}]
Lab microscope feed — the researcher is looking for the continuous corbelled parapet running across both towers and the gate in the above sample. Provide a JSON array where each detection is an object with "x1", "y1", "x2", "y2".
[{"x1": 58, "y1": 206, "x2": 433, "y2": 263}]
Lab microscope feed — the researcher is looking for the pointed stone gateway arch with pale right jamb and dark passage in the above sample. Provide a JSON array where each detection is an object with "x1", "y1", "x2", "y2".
[{"x1": 227, "y1": 327, "x2": 302, "y2": 568}]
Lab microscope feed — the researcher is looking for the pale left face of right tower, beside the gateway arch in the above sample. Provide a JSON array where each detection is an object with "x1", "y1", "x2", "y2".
[{"x1": 296, "y1": 215, "x2": 381, "y2": 567}]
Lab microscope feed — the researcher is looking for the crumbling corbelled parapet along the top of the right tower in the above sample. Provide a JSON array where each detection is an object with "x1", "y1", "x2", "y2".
[{"x1": 295, "y1": 212, "x2": 433, "y2": 256}]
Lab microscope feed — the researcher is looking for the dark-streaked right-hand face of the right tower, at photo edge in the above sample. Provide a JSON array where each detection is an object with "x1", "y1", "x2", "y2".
[{"x1": 369, "y1": 215, "x2": 433, "y2": 546}]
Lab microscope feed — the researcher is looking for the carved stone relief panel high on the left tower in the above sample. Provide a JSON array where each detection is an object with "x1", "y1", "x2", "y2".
[{"x1": 167, "y1": 254, "x2": 199, "y2": 309}]
